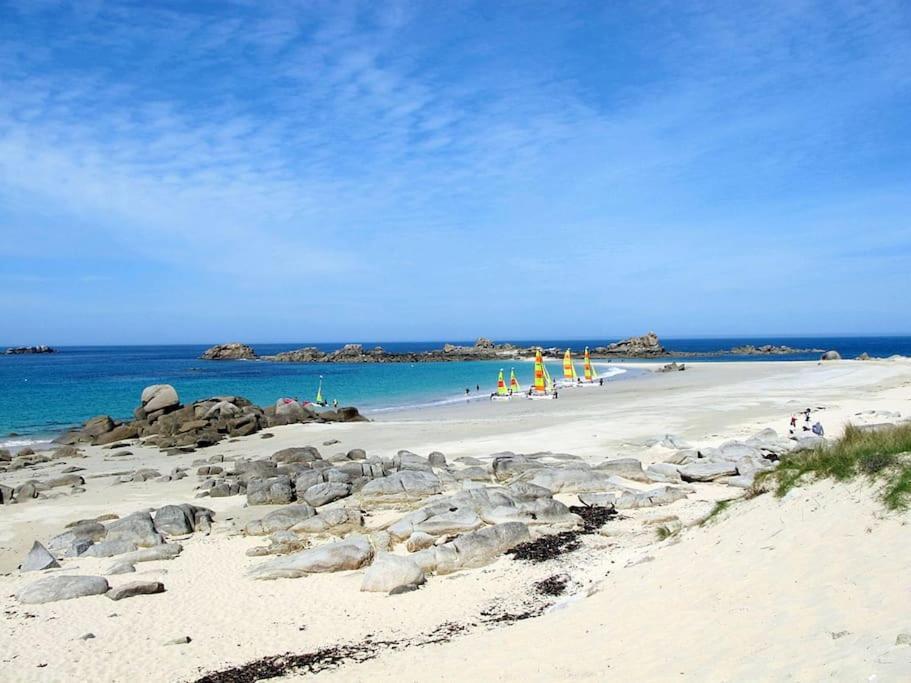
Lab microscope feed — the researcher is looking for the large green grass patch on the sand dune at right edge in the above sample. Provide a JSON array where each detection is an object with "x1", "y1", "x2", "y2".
[{"x1": 764, "y1": 424, "x2": 911, "y2": 511}]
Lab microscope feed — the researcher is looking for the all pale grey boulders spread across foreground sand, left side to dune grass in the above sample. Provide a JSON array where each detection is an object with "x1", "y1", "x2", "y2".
[{"x1": 8, "y1": 428, "x2": 824, "y2": 603}]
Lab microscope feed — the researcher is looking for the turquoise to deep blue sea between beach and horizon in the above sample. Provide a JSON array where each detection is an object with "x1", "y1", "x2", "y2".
[{"x1": 0, "y1": 337, "x2": 911, "y2": 446}]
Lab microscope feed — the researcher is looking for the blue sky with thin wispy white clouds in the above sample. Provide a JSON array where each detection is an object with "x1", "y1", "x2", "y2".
[{"x1": 0, "y1": 0, "x2": 911, "y2": 344}]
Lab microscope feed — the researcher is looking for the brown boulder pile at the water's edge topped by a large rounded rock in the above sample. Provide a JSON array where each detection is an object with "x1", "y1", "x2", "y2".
[{"x1": 56, "y1": 384, "x2": 366, "y2": 449}]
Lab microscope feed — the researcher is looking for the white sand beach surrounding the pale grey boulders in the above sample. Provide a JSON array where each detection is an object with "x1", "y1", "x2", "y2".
[{"x1": 0, "y1": 359, "x2": 911, "y2": 681}]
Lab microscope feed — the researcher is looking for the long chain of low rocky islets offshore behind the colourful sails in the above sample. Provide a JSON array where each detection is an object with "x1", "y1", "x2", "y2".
[{"x1": 200, "y1": 332, "x2": 840, "y2": 363}]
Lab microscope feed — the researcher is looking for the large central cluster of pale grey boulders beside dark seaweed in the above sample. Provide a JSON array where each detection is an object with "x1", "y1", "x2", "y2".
[{"x1": 233, "y1": 447, "x2": 704, "y2": 593}]
